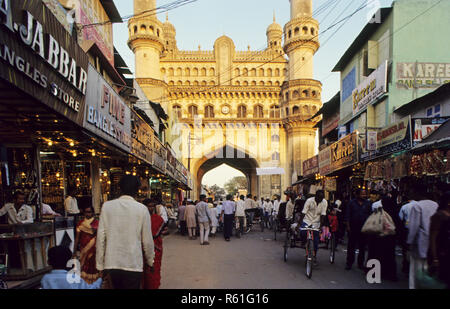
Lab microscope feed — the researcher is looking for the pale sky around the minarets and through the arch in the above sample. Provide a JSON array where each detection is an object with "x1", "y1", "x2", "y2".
[{"x1": 114, "y1": 0, "x2": 392, "y2": 185}]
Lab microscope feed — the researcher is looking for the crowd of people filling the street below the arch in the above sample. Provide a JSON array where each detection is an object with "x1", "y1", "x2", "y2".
[{"x1": 41, "y1": 175, "x2": 450, "y2": 289}]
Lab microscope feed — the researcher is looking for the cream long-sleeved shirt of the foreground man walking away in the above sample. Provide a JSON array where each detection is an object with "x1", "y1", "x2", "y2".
[{"x1": 96, "y1": 195, "x2": 155, "y2": 272}]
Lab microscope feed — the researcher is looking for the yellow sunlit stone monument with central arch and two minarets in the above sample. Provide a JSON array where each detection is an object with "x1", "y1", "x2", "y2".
[{"x1": 128, "y1": 0, "x2": 322, "y2": 197}]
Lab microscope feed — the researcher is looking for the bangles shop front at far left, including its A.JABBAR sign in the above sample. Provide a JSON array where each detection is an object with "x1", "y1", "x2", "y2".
[{"x1": 0, "y1": 1, "x2": 88, "y2": 287}]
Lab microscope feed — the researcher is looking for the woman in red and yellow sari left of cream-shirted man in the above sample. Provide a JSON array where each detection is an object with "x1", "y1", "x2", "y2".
[{"x1": 74, "y1": 207, "x2": 100, "y2": 284}]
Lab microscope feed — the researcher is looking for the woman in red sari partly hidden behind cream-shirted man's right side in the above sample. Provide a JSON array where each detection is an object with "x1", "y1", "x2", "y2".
[{"x1": 142, "y1": 199, "x2": 164, "y2": 290}]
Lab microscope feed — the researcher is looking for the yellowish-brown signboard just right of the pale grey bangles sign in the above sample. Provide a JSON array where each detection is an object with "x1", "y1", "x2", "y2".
[{"x1": 131, "y1": 110, "x2": 154, "y2": 164}]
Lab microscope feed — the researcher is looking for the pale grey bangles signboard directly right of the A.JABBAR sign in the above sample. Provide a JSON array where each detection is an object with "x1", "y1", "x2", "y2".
[{"x1": 83, "y1": 65, "x2": 131, "y2": 153}]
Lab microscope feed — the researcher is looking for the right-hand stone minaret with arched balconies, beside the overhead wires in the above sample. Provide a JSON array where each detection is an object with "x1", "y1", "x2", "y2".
[{"x1": 281, "y1": 0, "x2": 322, "y2": 180}]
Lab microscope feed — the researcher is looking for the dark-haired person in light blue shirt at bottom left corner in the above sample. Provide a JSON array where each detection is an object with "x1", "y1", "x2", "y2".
[{"x1": 41, "y1": 246, "x2": 102, "y2": 290}]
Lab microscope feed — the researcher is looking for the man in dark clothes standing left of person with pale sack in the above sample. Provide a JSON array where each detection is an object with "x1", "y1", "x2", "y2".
[{"x1": 344, "y1": 189, "x2": 372, "y2": 270}]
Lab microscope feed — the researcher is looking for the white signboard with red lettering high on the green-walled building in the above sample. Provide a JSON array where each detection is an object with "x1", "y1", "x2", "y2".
[{"x1": 352, "y1": 61, "x2": 388, "y2": 115}]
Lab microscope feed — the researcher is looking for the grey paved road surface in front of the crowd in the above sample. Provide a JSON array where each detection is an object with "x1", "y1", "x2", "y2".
[{"x1": 161, "y1": 226, "x2": 408, "y2": 289}]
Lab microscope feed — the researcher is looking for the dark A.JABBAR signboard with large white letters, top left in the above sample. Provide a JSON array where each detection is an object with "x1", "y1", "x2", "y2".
[{"x1": 0, "y1": 0, "x2": 89, "y2": 126}]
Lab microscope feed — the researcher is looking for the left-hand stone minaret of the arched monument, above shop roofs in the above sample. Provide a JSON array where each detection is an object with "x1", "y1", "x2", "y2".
[{"x1": 128, "y1": 0, "x2": 167, "y2": 103}]
